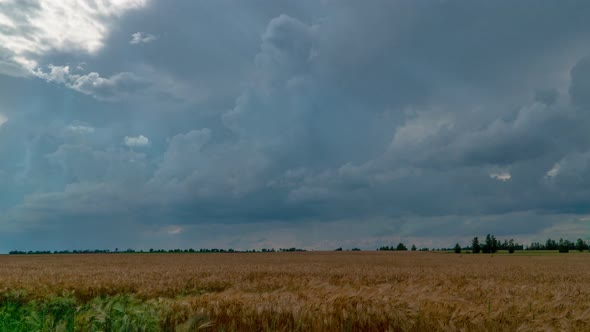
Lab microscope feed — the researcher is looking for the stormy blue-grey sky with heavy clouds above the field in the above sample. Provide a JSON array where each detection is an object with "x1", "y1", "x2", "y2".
[{"x1": 0, "y1": 0, "x2": 590, "y2": 252}]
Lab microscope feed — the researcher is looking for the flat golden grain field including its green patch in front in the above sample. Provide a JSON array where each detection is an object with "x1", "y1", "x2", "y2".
[{"x1": 0, "y1": 251, "x2": 590, "y2": 331}]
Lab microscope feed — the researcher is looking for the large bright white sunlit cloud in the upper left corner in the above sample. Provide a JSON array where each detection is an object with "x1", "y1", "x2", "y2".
[{"x1": 0, "y1": 0, "x2": 148, "y2": 76}]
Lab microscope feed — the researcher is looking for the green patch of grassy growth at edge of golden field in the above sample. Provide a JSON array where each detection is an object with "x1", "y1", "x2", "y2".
[{"x1": 0, "y1": 292, "x2": 211, "y2": 332}]
